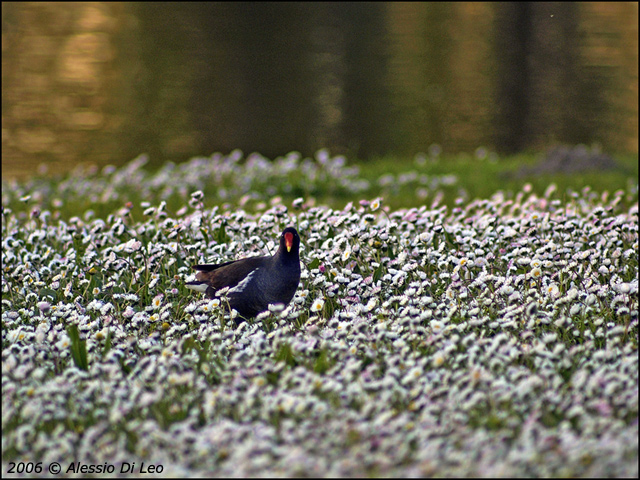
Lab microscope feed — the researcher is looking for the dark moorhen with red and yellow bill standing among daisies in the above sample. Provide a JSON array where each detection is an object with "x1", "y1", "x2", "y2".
[{"x1": 186, "y1": 227, "x2": 300, "y2": 318}]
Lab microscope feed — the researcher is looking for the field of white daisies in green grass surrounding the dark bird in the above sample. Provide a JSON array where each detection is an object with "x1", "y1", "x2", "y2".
[{"x1": 2, "y1": 152, "x2": 638, "y2": 477}]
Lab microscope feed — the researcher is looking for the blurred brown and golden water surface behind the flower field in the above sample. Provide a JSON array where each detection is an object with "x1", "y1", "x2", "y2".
[{"x1": 2, "y1": 2, "x2": 638, "y2": 175}]
